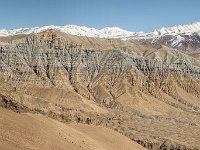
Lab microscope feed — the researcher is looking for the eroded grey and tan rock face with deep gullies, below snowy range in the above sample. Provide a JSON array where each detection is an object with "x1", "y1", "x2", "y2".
[{"x1": 0, "y1": 30, "x2": 200, "y2": 150}]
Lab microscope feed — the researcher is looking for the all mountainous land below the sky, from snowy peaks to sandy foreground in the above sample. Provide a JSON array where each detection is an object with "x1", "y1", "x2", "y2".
[{"x1": 0, "y1": 23, "x2": 200, "y2": 150}]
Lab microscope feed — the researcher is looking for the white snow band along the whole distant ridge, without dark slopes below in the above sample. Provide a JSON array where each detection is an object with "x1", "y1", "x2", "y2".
[{"x1": 0, "y1": 22, "x2": 200, "y2": 40}]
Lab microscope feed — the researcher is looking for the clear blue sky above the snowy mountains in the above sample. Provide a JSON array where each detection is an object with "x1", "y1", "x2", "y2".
[{"x1": 0, "y1": 0, "x2": 200, "y2": 31}]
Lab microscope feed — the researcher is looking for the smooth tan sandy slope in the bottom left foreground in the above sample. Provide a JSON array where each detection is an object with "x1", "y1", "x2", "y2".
[{"x1": 0, "y1": 108, "x2": 144, "y2": 150}]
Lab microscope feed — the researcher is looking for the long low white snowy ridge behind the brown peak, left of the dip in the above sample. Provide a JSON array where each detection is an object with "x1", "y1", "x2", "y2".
[{"x1": 0, "y1": 25, "x2": 133, "y2": 38}]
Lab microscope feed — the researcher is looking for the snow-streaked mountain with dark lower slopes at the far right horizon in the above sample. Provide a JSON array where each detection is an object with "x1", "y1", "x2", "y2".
[{"x1": 128, "y1": 22, "x2": 200, "y2": 51}]
